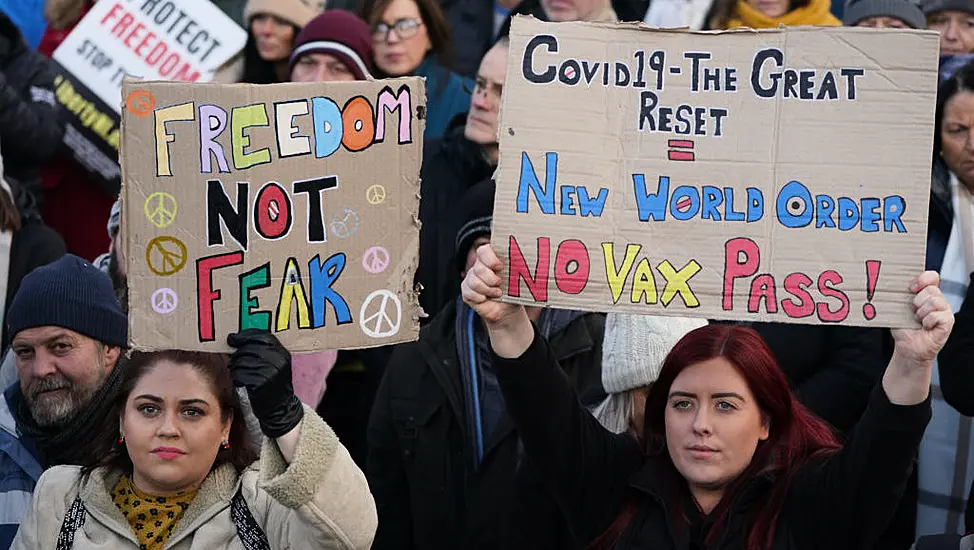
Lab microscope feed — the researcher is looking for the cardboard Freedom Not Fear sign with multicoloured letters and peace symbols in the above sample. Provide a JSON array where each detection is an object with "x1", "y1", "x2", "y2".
[{"x1": 121, "y1": 78, "x2": 426, "y2": 352}]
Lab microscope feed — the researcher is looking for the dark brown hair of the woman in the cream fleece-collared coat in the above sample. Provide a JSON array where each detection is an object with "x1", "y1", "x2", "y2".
[{"x1": 85, "y1": 350, "x2": 257, "y2": 473}]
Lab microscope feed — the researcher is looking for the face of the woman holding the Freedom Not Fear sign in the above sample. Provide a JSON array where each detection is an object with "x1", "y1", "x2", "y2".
[{"x1": 120, "y1": 360, "x2": 233, "y2": 495}]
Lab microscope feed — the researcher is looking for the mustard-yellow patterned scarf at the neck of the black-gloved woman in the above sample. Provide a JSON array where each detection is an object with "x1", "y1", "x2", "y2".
[{"x1": 112, "y1": 476, "x2": 196, "y2": 550}]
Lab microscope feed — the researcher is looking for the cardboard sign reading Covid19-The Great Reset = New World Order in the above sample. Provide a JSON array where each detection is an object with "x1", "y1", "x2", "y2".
[{"x1": 500, "y1": 17, "x2": 938, "y2": 326}]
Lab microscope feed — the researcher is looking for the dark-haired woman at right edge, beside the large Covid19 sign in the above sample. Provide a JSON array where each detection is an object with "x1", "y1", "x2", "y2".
[{"x1": 917, "y1": 59, "x2": 974, "y2": 535}]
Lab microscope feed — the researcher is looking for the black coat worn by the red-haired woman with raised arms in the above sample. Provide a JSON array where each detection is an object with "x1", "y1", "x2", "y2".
[{"x1": 494, "y1": 330, "x2": 931, "y2": 550}]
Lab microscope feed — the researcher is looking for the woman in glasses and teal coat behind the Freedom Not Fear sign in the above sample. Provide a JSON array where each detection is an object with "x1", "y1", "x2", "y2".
[{"x1": 362, "y1": 0, "x2": 473, "y2": 141}]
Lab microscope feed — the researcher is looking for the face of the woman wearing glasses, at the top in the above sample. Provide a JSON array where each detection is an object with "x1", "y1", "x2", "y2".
[{"x1": 372, "y1": 0, "x2": 433, "y2": 76}]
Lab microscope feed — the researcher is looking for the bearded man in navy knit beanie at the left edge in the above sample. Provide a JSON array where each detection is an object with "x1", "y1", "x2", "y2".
[{"x1": 0, "y1": 255, "x2": 128, "y2": 549}]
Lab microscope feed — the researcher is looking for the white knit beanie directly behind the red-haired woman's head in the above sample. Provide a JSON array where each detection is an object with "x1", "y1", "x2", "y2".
[{"x1": 602, "y1": 313, "x2": 707, "y2": 394}]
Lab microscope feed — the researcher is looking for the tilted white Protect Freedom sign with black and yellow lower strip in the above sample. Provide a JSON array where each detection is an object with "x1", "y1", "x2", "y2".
[{"x1": 53, "y1": 0, "x2": 247, "y2": 194}]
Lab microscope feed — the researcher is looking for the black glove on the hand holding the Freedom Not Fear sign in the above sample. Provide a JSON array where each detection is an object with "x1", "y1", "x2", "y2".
[{"x1": 227, "y1": 328, "x2": 304, "y2": 439}]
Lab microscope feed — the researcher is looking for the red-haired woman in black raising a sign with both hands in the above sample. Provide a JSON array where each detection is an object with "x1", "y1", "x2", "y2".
[{"x1": 462, "y1": 245, "x2": 954, "y2": 550}]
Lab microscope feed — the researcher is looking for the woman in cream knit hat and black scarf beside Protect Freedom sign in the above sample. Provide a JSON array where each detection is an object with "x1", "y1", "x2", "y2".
[{"x1": 213, "y1": 0, "x2": 325, "y2": 84}]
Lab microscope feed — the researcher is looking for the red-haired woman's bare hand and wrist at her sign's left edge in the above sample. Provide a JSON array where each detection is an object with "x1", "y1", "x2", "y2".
[{"x1": 460, "y1": 244, "x2": 534, "y2": 358}]
